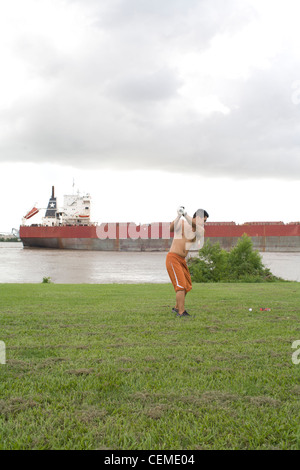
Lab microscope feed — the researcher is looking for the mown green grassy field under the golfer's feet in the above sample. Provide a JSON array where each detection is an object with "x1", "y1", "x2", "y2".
[{"x1": 0, "y1": 282, "x2": 300, "y2": 450}]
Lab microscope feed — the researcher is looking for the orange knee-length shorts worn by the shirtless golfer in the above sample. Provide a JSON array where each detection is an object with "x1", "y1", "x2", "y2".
[{"x1": 166, "y1": 253, "x2": 192, "y2": 292}]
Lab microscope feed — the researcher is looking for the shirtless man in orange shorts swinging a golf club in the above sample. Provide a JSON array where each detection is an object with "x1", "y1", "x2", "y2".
[{"x1": 166, "y1": 206, "x2": 208, "y2": 317}]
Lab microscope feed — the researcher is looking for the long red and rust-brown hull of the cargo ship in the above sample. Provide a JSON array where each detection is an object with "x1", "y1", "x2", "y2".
[{"x1": 20, "y1": 223, "x2": 300, "y2": 252}]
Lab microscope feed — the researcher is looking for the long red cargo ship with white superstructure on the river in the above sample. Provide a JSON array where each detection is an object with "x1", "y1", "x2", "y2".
[{"x1": 19, "y1": 187, "x2": 300, "y2": 252}]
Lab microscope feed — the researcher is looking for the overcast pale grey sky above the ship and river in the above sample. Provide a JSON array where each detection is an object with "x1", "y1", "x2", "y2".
[{"x1": 0, "y1": 0, "x2": 300, "y2": 231}]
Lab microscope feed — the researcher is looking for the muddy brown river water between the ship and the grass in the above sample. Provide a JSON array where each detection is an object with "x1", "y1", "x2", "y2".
[{"x1": 0, "y1": 242, "x2": 300, "y2": 284}]
